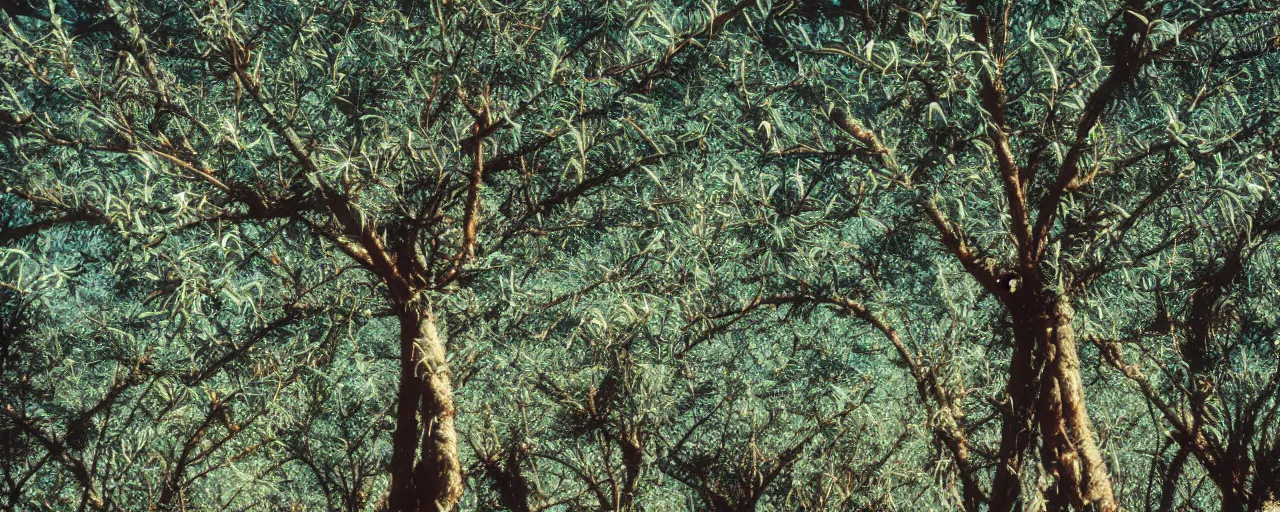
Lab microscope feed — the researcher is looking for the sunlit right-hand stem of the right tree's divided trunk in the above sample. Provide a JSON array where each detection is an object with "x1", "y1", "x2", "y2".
[{"x1": 1039, "y1": 300, "x2": 1120, "y2": 512}]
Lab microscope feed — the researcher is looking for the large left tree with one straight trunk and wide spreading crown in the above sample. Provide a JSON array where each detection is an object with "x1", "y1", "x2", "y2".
[{"x1": 5, "y1": 1, "x2": 746, "y2": 509}]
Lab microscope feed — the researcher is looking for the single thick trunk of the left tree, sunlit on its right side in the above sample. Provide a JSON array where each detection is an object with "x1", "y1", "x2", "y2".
[{"x1": 388, "y1": 303, "x2": 462, "y2": 512}]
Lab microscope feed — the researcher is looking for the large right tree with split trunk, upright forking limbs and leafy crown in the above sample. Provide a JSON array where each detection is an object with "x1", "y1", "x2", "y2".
[{"x1": 691, "y1": 1, "x2": 1277, "y2": 511}]
